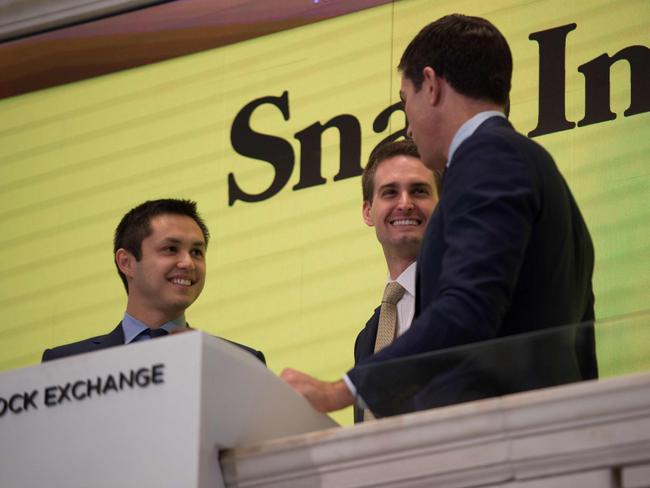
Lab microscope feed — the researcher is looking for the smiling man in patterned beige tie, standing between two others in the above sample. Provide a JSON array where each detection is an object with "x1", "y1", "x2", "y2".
[{"x1": 354, "y1": 140, "x2": 440, "y2": 422}]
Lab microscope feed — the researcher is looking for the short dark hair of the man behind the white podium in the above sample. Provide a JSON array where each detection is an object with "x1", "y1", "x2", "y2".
[{"x1": 113, "y1": 198, "x2": 210, "y2": 294}]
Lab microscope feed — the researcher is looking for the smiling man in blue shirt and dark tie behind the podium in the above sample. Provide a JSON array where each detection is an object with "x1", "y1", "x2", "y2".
[{"x1": 43, "y1": 199, "x2": 264, "y2": 362}]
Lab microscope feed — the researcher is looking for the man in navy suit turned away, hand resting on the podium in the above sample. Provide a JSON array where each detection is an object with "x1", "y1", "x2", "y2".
[{"x1": 283, "y1": 15, "x2": 597, "y2": 414}]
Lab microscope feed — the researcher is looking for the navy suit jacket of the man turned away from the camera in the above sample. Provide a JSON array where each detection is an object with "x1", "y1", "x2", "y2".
[{"x1": 348, "y1": 117, "x2": 597, "y2": 414}]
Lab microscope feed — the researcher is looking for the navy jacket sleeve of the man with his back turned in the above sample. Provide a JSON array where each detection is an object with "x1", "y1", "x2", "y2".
[{"x1": 349, "y1": 130, "x2": 539, "y2": 370}]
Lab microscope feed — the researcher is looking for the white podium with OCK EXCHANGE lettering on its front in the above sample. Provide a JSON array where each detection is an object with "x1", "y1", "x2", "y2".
[{"x1": 0, "y1": 332, "x2": 336, "y2": 488}]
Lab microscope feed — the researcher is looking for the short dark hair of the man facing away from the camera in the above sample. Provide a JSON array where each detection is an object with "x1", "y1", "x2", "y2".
[{"x1": 397, "y1": 14, "x2": 512, "y2": 106}]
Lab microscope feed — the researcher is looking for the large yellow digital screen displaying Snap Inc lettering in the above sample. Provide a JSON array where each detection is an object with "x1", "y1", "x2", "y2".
[{"x1": 0, "y1": 0, "x2": 650, "y2": 423}]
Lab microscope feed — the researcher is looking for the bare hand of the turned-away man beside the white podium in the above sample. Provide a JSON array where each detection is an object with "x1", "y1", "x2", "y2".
[{"x1": 280, "y1": 368, "x2": 354, "y2": 413}]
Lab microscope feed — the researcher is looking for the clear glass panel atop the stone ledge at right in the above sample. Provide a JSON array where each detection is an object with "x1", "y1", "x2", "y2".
[{"x1": 353, "y1": 312, "x2": 650, "y2": 417}]
